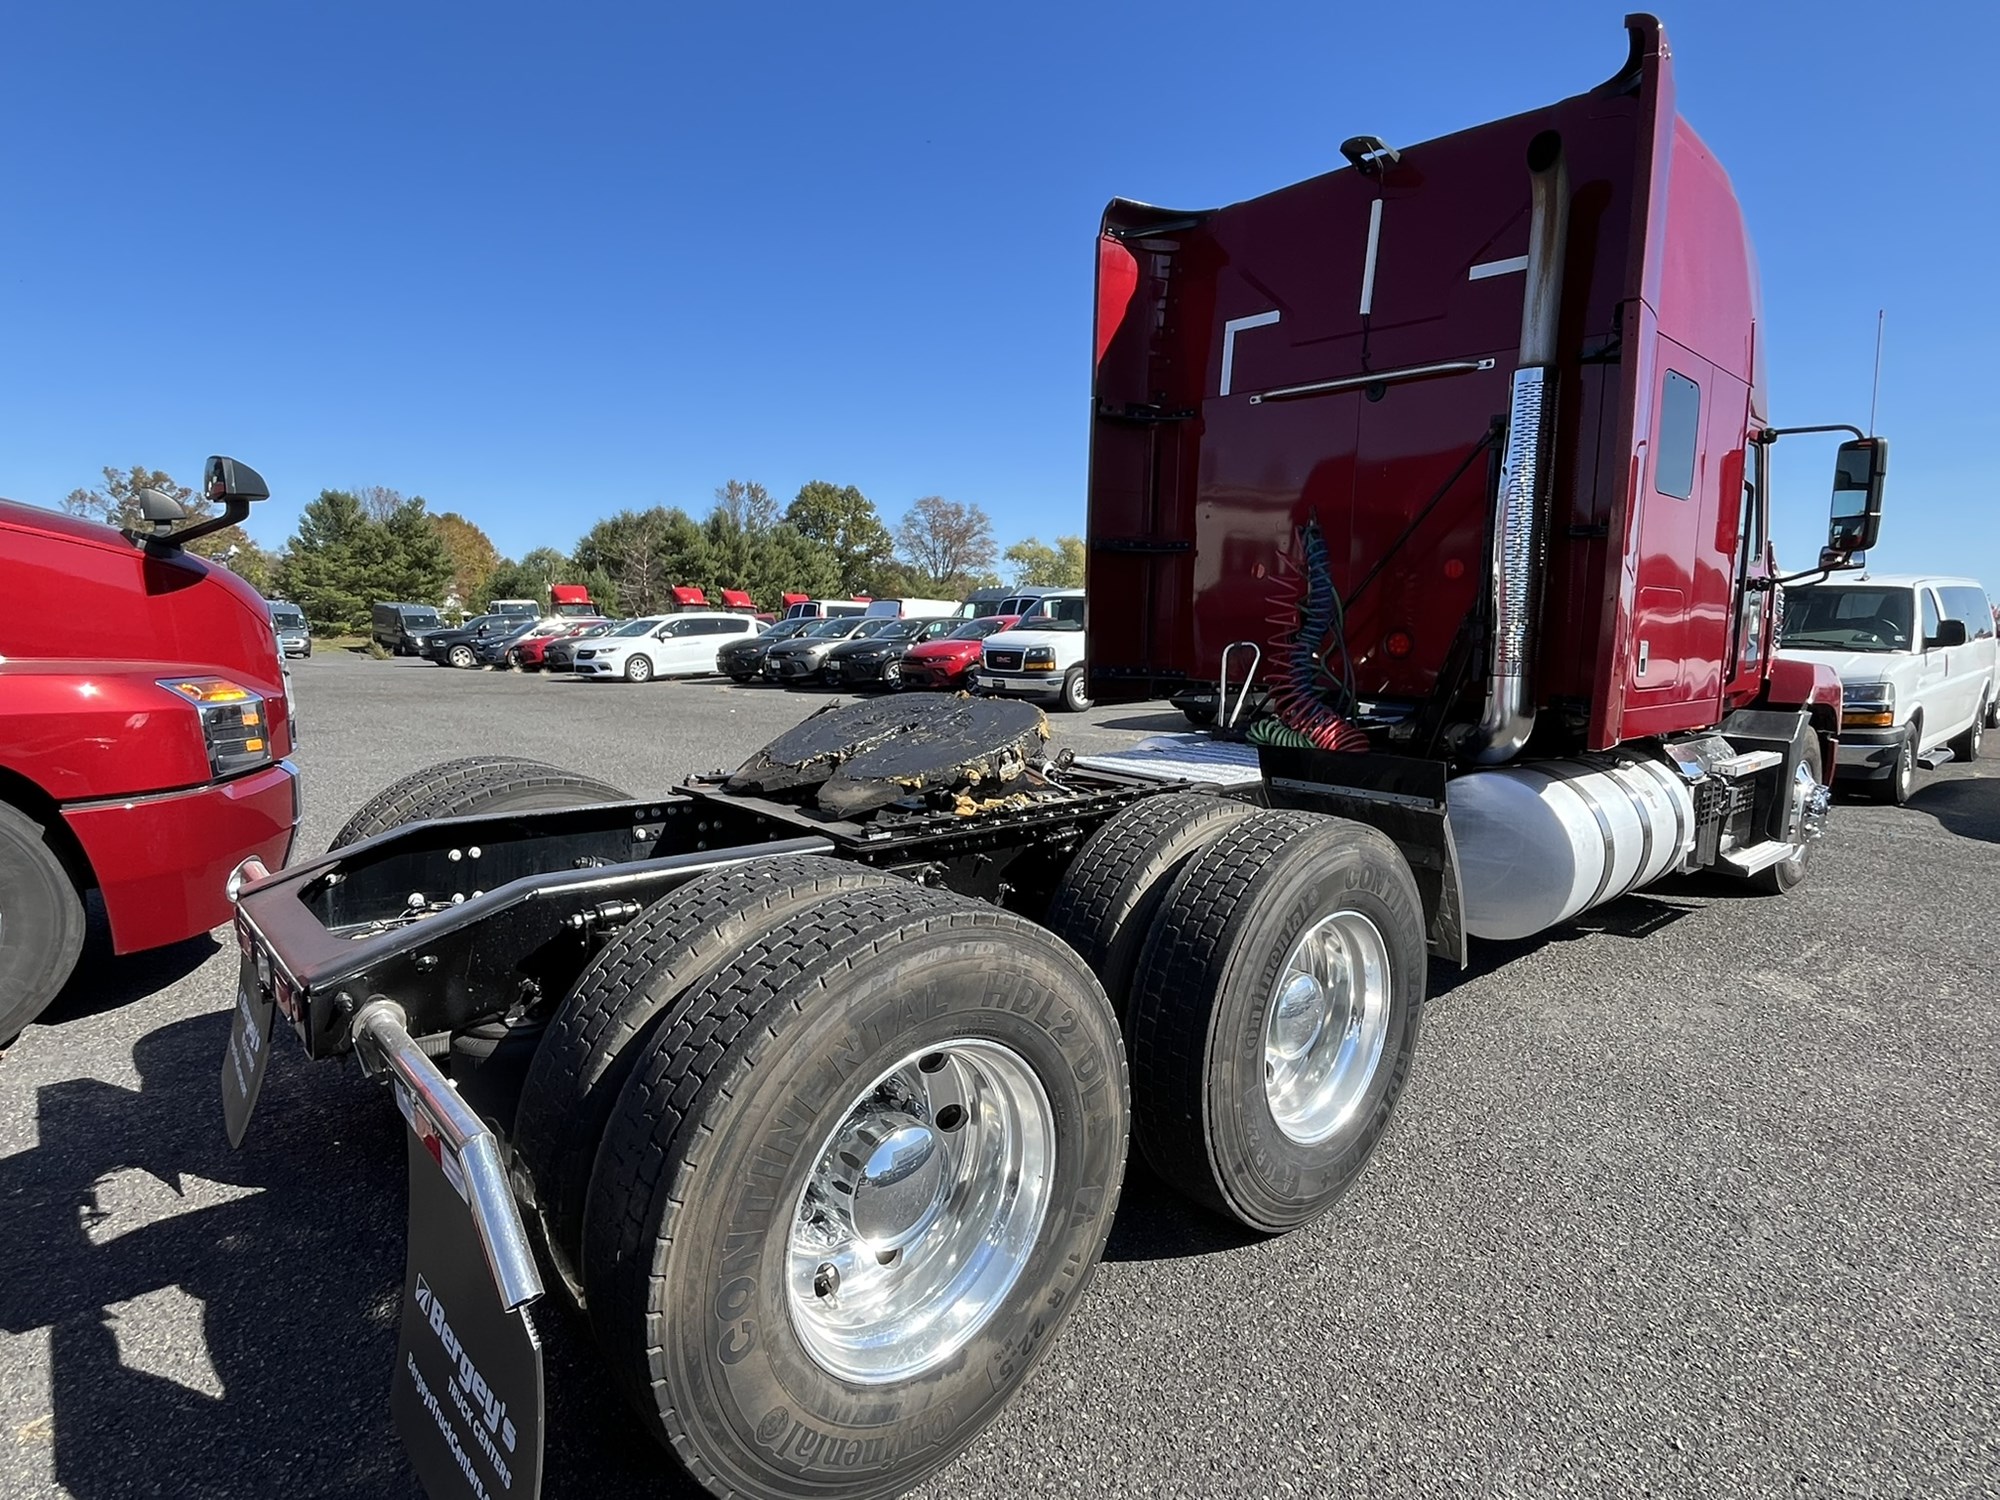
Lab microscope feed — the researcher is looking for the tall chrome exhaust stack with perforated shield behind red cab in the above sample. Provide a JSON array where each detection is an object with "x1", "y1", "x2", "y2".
[{"x1": 1472, "y1": 130, "x2": 1570, "y2": 766}]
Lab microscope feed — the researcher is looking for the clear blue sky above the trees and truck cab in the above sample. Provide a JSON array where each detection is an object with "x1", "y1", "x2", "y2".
[{"x1": 0, "y1": 0, "x2": 2000, "y2": 590}]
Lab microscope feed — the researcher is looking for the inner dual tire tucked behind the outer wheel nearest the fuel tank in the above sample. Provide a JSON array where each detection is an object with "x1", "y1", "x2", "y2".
[{"x1": 1048, "y1": 792, "x2": 1256, "y2": 1016}]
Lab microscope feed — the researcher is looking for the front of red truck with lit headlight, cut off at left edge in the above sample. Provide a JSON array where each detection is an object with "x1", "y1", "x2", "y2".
[{"x1": 0, "y1": 458, "x2": 300, "y2": 1044}]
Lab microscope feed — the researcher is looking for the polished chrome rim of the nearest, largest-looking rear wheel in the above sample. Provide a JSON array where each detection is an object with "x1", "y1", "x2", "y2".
[{"x1": 786, "y1": 1038, "x2": 1056, "y2": 1386}]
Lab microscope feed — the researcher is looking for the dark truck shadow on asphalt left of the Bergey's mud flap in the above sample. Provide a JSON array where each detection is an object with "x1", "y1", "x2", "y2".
[{"x1": 0, "y1": 1014, "x2": 416, "y2": 1500}]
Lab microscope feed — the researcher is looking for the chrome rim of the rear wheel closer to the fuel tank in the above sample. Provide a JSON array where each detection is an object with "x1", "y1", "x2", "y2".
[{"x1": 1264, "y1": 912, "x2": 1392, "y2": 1146}]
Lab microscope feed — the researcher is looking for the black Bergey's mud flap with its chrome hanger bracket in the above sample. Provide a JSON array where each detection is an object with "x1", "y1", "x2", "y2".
[{"x1": 354, "y1": 998, "x2": 544, "y2": 1500}]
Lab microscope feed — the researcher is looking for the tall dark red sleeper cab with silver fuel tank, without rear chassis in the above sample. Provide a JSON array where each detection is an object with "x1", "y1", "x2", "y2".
[{"x1": 1090, "y1": 16, "x2": 1888, "y2": 936}]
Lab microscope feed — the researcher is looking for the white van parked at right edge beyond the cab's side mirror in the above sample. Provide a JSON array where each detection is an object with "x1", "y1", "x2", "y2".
[{"x1": 1778, "y1": 574, "x2": 2000, "y2": 802}]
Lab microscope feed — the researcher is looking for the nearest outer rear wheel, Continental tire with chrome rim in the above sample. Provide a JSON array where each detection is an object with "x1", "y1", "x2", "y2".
[{"x1": 584, "y1": 888, "x2": 1128, "y2": 1500}]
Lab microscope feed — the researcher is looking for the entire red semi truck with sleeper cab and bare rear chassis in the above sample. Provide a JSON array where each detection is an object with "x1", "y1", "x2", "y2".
[{"x1": 224, "y1": 16, "x2": 1886, "y2": 1498}]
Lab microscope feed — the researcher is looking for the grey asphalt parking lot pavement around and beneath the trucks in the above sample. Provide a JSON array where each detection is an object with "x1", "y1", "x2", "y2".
[{"x1": 0, "y1": 654, "x2": 2000, "y2": 1500}]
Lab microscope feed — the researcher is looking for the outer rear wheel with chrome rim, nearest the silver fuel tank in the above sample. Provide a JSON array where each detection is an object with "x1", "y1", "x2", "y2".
[{"x1": 1126, "y1": 812, "x2": 1430, "y2": 1234}]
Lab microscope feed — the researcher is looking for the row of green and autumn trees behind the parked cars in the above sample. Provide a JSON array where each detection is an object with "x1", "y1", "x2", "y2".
[{"x1": 62, "y1": 466, "x2": 1084, "y2": 632}]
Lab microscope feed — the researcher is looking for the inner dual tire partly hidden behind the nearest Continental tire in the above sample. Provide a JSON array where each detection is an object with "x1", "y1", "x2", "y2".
[{"x1": 514, "y1": 854, "x2": 910, "y2": 1302}]
